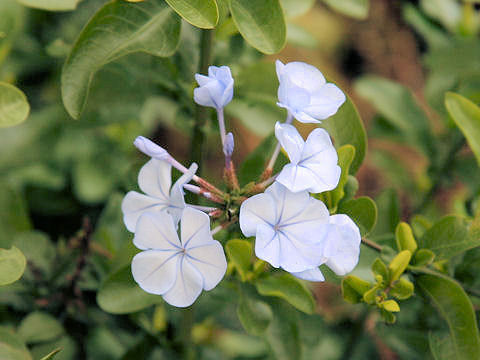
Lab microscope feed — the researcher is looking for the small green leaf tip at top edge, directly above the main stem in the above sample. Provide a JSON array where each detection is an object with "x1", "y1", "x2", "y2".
[{"x1": 165, "y1": 0, "x2": 218, "y2": 29}]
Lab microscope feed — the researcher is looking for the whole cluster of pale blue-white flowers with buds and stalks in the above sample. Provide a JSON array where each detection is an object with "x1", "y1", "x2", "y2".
[{"x1": 122, "y1": 61, "x2": 361, "y2": 307}]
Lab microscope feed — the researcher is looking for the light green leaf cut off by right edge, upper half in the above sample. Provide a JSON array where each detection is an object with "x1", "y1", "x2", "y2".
[{"x1": 445, "y1": 93, "x2": 480, "y2": 164}]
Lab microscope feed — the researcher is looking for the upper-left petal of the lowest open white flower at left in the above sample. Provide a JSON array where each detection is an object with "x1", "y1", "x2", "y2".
[{"x1": 133, "y1": 211, "x2": 181, "y2": 250}]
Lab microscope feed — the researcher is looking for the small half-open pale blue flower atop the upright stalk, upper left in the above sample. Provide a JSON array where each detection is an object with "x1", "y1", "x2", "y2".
[{"x1": 193, "y1": 66, "x2": 233, "y2": 110}]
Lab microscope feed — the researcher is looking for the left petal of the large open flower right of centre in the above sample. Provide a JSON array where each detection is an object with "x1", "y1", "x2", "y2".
[{"x1": 239, "y1": 193, "x2": 277, "y2": 236}]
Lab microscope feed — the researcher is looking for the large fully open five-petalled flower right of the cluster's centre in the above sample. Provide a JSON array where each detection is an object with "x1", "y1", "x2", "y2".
[{"x1": 240, "y1": 182, "x2": 329, "y2": 272}]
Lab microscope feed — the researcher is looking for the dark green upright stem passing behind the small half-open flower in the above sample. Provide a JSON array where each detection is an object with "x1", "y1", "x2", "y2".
[{"x1": 190, "y1": 30, "x2": 214, "y2": 173}]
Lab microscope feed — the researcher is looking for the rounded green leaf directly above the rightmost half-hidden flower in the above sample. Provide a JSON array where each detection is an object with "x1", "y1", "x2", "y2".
[{"x1": 338, "y1": 196, "x2": 377, "y2": 236}]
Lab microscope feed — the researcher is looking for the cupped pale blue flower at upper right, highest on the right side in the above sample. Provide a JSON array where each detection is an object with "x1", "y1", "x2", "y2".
[{"x1": 276, "y1": 60, "x2": 345, "y2": 123}]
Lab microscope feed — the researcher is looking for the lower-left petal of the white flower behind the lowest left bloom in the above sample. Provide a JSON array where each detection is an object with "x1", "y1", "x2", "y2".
[{"x1": 122, "y1": 191, "x2": 168, "y2": 232}]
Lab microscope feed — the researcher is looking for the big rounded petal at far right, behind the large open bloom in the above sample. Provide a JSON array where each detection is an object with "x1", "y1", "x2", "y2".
[{"x1": 324, "y1": 214, "x2": 361, "y2": 276}]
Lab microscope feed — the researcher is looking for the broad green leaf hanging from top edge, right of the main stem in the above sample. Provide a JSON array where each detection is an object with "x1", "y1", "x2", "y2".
[{"x1": 230, "y1": 0, "x2": 287, "y2": 54}]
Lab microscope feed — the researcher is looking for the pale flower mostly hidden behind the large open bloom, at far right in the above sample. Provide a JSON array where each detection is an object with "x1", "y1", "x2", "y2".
[{"x1": 292, "y1": 214, "x2": 361, "y2": 281}]
